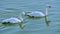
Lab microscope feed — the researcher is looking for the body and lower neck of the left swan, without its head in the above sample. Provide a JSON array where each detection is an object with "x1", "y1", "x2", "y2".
[{"x1": 2, "y1": 16, "x2": 23, "y2": 24}]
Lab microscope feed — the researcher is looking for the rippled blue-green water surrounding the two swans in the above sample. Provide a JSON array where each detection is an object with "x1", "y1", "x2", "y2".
[{"x1": 0, "y1": 0, "x2": 60, "y2": 34}]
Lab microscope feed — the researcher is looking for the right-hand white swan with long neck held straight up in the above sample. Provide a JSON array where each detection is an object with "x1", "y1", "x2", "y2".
[{"x1": 22, "y1": 4, "x2": 51, "y2": 17}]
